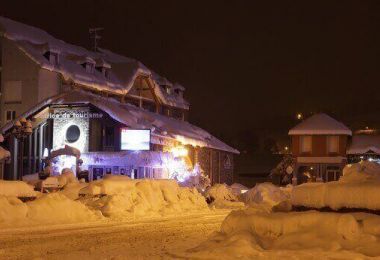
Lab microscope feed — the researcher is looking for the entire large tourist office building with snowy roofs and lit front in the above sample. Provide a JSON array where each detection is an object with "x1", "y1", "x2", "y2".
[{"x1": 0, "y1": 17, "x2": 238, "y2": 183}]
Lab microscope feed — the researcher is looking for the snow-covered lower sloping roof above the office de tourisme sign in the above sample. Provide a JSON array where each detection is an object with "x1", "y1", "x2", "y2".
[{"x1": 0, "y1": 90, "x2": 239, "y2": 154}]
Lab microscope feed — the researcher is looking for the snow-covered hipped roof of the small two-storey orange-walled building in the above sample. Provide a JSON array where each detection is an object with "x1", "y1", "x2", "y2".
[{"x1": 289, "y1": 113, "x2": 352, "y2": 135}]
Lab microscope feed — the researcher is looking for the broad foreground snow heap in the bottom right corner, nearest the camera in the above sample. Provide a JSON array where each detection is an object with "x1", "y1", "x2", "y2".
[{"x1": 186, "y1": 208, "x2": 380, "y2": 259}]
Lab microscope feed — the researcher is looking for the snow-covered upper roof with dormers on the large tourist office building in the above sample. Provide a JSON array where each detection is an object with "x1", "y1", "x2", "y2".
[{"x1": 0, "y1": 16, "x2": 189, "y2": 109}]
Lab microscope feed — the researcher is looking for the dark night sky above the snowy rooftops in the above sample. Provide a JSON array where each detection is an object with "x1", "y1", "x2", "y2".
[{"x1": 0, "y1": 0, "x2": 380, "y2": 144}]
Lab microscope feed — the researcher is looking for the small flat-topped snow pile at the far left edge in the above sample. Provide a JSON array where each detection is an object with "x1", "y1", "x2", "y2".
[{"x1": 0, "y1": 180, "x2": 36, "y2": 198}]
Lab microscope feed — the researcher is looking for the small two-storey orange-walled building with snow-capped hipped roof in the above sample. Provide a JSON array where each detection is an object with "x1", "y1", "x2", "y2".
[{"x1": 289, "y1": 114, "x2": 352, "y2": 184}]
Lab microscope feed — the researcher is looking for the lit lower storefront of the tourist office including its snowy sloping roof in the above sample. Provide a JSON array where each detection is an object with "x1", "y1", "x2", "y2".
[{"x1": 3, "y1": 92, "x2": 238, "y2": 182}]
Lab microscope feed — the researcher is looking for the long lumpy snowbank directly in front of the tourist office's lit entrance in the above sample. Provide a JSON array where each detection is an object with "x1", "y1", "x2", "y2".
[{"x1": 79, "y1": 176, "x2": 208, "y2": 219}]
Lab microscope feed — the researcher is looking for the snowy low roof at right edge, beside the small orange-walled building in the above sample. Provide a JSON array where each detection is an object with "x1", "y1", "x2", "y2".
[{"x1": 347, "y1": 135, "x2": 380, "y2": 154}]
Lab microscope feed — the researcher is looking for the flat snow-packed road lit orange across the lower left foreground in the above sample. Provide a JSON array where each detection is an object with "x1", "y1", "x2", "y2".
[{"x1": 0, "y1": 210, "x2": 229, "y2": 260}]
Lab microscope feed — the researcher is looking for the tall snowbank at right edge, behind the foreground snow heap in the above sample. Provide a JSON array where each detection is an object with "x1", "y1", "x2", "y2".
[{"x1": 291, "y1": 162, "x2": 380, "y2": 210}]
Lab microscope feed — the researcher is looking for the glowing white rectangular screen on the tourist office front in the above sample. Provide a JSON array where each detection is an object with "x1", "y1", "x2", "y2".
[{"x1": 121, "y1": 129, "x2": 150, "y2": 151}]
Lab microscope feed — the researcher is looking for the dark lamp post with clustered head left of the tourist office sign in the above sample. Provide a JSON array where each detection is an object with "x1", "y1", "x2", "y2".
[{"x1": 12, "y1": 118, "x2": 33, "y2": 180}]
